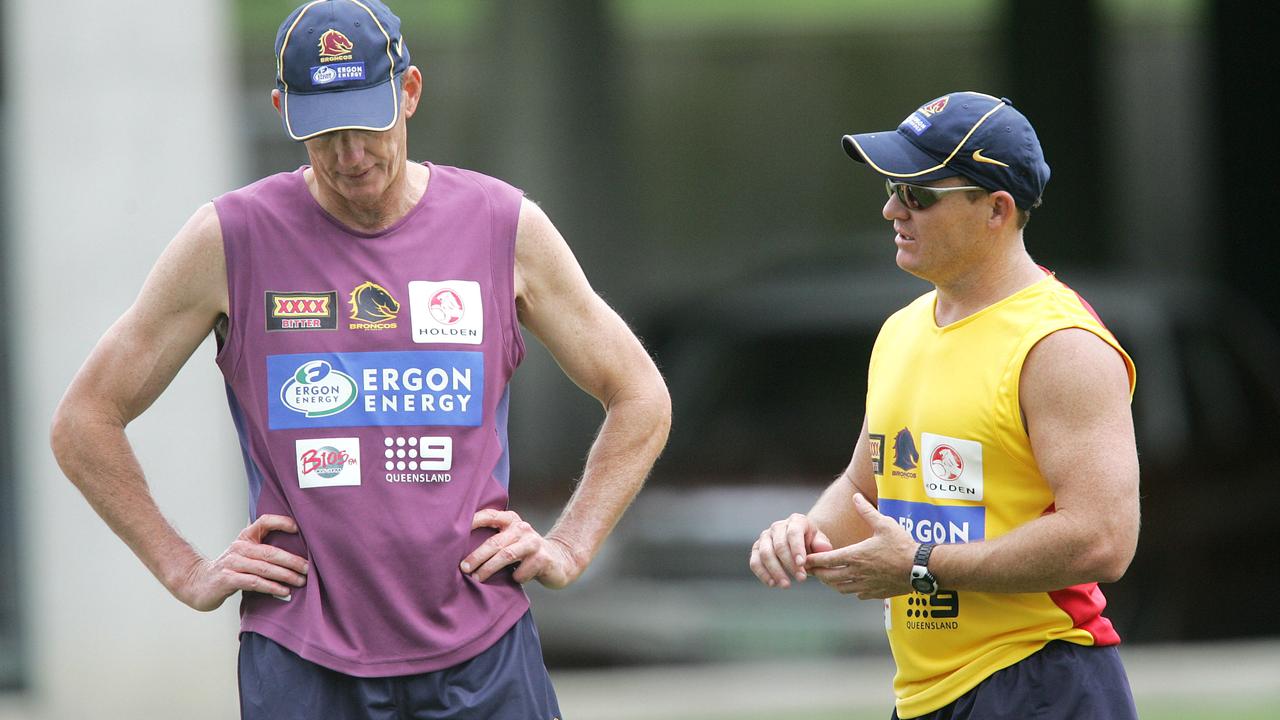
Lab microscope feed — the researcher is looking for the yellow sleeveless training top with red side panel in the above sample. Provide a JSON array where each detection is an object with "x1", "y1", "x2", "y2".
[{"x1": 867, "y1": 269, "x2": 1135, "y2": 717}]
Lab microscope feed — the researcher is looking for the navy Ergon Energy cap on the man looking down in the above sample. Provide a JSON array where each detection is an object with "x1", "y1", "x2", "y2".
[{"x1": 275, "y1": 0, "x2": 408, "y2": 140}]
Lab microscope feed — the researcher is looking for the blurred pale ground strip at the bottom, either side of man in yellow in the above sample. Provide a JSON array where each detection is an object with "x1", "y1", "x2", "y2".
[{"x1": 553, "y1": 639, "x2": 1280, "y2": 720}]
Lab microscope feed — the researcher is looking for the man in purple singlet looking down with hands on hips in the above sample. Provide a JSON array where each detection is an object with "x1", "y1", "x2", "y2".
[{"x1": 52, "y1": 0, "x2": 671, "y2": 720}]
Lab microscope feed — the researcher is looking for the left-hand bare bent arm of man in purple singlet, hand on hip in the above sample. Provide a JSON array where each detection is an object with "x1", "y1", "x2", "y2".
[{"x1": 51, "y1": 205, "x2": 312, "y2": 610}]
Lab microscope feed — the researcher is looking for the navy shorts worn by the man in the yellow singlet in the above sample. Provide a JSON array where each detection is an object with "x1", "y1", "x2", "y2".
[{"x1": 892, "y1": 641, "x2": 1138, "y2": 720}]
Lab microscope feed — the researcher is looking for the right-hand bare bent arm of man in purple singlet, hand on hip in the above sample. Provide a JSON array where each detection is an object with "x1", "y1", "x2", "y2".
[{"x1": 462, "y1": 194, "x2": 671, "y2": 588}]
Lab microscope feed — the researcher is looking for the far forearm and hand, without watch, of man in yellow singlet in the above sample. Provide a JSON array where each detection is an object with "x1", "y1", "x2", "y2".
[{"x1": 748, "y1": 418, "x2": 877, "y2": 588}]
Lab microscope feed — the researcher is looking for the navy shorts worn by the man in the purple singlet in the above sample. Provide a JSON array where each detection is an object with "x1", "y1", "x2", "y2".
[{"x1": 239, "y1": 604, "x2": 561, "y2": 720}]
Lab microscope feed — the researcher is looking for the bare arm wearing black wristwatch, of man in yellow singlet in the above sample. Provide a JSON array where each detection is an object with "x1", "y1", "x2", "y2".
[{"x1": 809, "y1": 329, "x2": 1138, "y2": 598}]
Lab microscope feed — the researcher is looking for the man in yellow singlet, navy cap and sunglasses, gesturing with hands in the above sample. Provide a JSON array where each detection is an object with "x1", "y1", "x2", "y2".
[{"x1": 750, "y1": 92, "x2": 1138, "y2": 720}]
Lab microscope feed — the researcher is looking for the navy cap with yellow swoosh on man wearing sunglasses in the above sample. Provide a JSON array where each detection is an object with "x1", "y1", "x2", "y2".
[{"x1": 841, "y1": 92, "x2": 1048, "y2": 210}]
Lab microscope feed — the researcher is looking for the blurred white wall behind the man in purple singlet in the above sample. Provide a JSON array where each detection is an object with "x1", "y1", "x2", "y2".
[{"x1": 0, "y1": 0, "x2": 245, "y2": 719}]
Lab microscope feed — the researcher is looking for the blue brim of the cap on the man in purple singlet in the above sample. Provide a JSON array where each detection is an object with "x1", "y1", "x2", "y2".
[{"x1": 280, "y1": 78, "x2": 401, "y2": 141}]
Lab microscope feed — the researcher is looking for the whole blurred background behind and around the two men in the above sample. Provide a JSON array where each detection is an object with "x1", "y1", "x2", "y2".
[{"x1": 0, "y1": 0, "x2": 1280, "y2": 720}]
